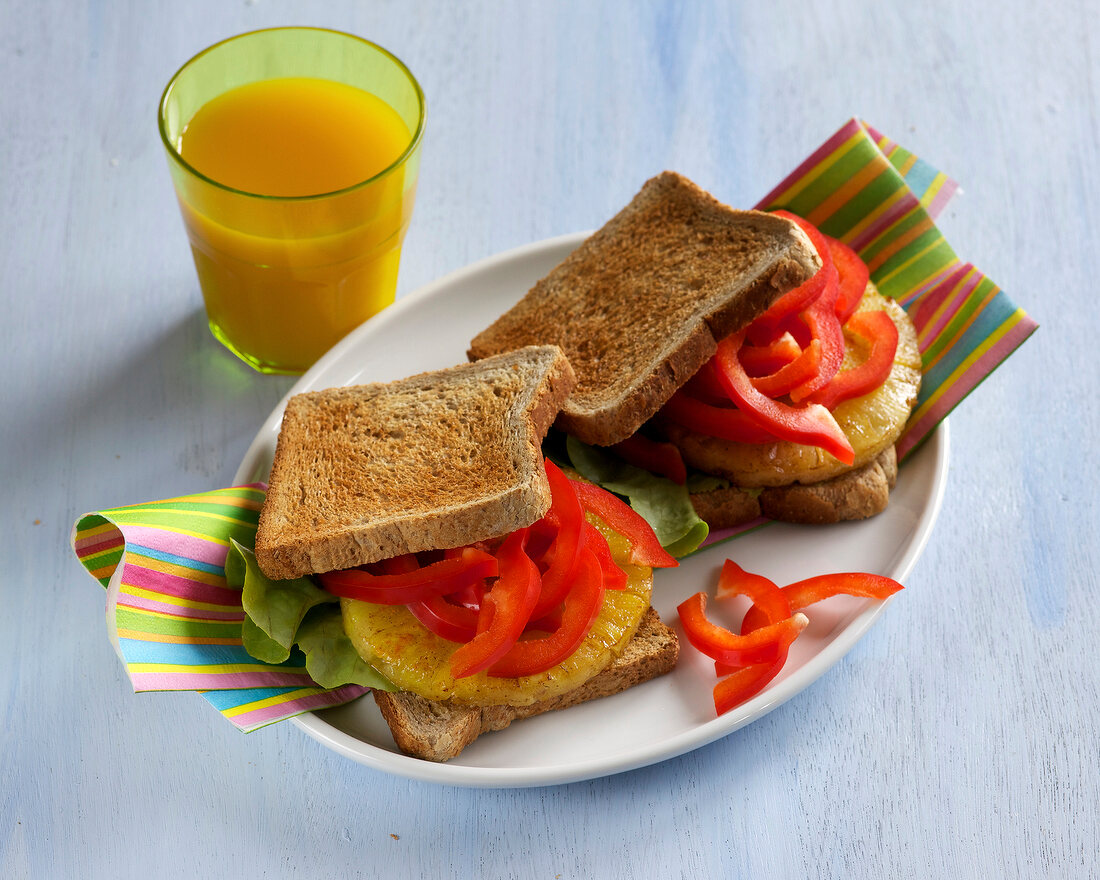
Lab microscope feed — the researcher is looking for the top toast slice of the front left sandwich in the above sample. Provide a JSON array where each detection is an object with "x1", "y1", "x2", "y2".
[{"x1": 255, "y1": 345, "x2": 575, "y2": 579}]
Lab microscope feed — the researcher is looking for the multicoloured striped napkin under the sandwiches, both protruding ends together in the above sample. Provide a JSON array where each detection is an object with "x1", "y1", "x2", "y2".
[{"x1": 72, "y1": 119, "x2": 1036, "y2": 730}]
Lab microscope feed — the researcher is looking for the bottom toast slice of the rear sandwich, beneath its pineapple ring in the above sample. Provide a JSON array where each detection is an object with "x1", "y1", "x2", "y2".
[{"x1": 691, "y1": 446, "x2": 898, "y2": 529}]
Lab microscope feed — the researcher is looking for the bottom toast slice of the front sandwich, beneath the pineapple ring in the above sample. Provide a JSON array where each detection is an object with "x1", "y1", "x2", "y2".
[{"x1": 374, "y1": 608, "x2": 680, "y2": 761}]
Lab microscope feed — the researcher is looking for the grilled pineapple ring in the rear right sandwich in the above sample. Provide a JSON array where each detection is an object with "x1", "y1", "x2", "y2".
[{"x1": 666, "y1": 284, "x2": 921, "y2": 488}]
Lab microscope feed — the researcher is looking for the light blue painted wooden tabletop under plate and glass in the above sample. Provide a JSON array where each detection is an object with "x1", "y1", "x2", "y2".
[{"x1": 0, "y1": 0, "x2": 1100, "y2": 878}]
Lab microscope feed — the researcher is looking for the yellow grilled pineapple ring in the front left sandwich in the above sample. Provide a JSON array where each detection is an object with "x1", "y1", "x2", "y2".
[{"x1": 340, "y1": 515, "x2": 653, "y2": 706}]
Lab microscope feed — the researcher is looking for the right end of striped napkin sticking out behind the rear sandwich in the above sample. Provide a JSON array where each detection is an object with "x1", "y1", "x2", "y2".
[{"x1": 757, "y1": 119, "x2": 1037, "y2": 459}]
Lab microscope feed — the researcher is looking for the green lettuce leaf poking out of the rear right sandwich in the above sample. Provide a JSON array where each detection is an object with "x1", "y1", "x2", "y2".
[{"x1": 565, "y1": 437, "x2": 710, "y2": 557}]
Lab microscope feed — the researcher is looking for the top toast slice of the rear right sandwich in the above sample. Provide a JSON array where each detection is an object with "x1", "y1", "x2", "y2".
[{"x1": 469, "y1": 172, "x2": 821, "y2": 446}]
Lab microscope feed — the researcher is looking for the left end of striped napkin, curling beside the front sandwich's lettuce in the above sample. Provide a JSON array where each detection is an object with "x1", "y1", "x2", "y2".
[{"x1": 72, "y1": 485, "x2": 366, "y2": 730}]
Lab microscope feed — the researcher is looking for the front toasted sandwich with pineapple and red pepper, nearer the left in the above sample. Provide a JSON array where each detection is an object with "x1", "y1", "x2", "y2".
[{"x1": 255, "y1": 345, "x2": 679, "y2": 761}]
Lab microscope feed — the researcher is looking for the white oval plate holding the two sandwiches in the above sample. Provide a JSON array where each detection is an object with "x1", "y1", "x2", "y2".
[{"x1": 235, "y1": 233, "x2": 948, "y2": 788}]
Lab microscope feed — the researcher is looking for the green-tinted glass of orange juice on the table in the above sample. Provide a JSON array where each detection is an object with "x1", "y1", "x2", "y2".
[{"x1": 160, "y1": 28, "x2": 425, "y2": 373}]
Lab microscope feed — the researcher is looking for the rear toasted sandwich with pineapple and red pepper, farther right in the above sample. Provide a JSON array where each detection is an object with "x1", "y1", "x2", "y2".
[{"x1": 469, "y1": 172, "x2": 921, "y2": 528}]
